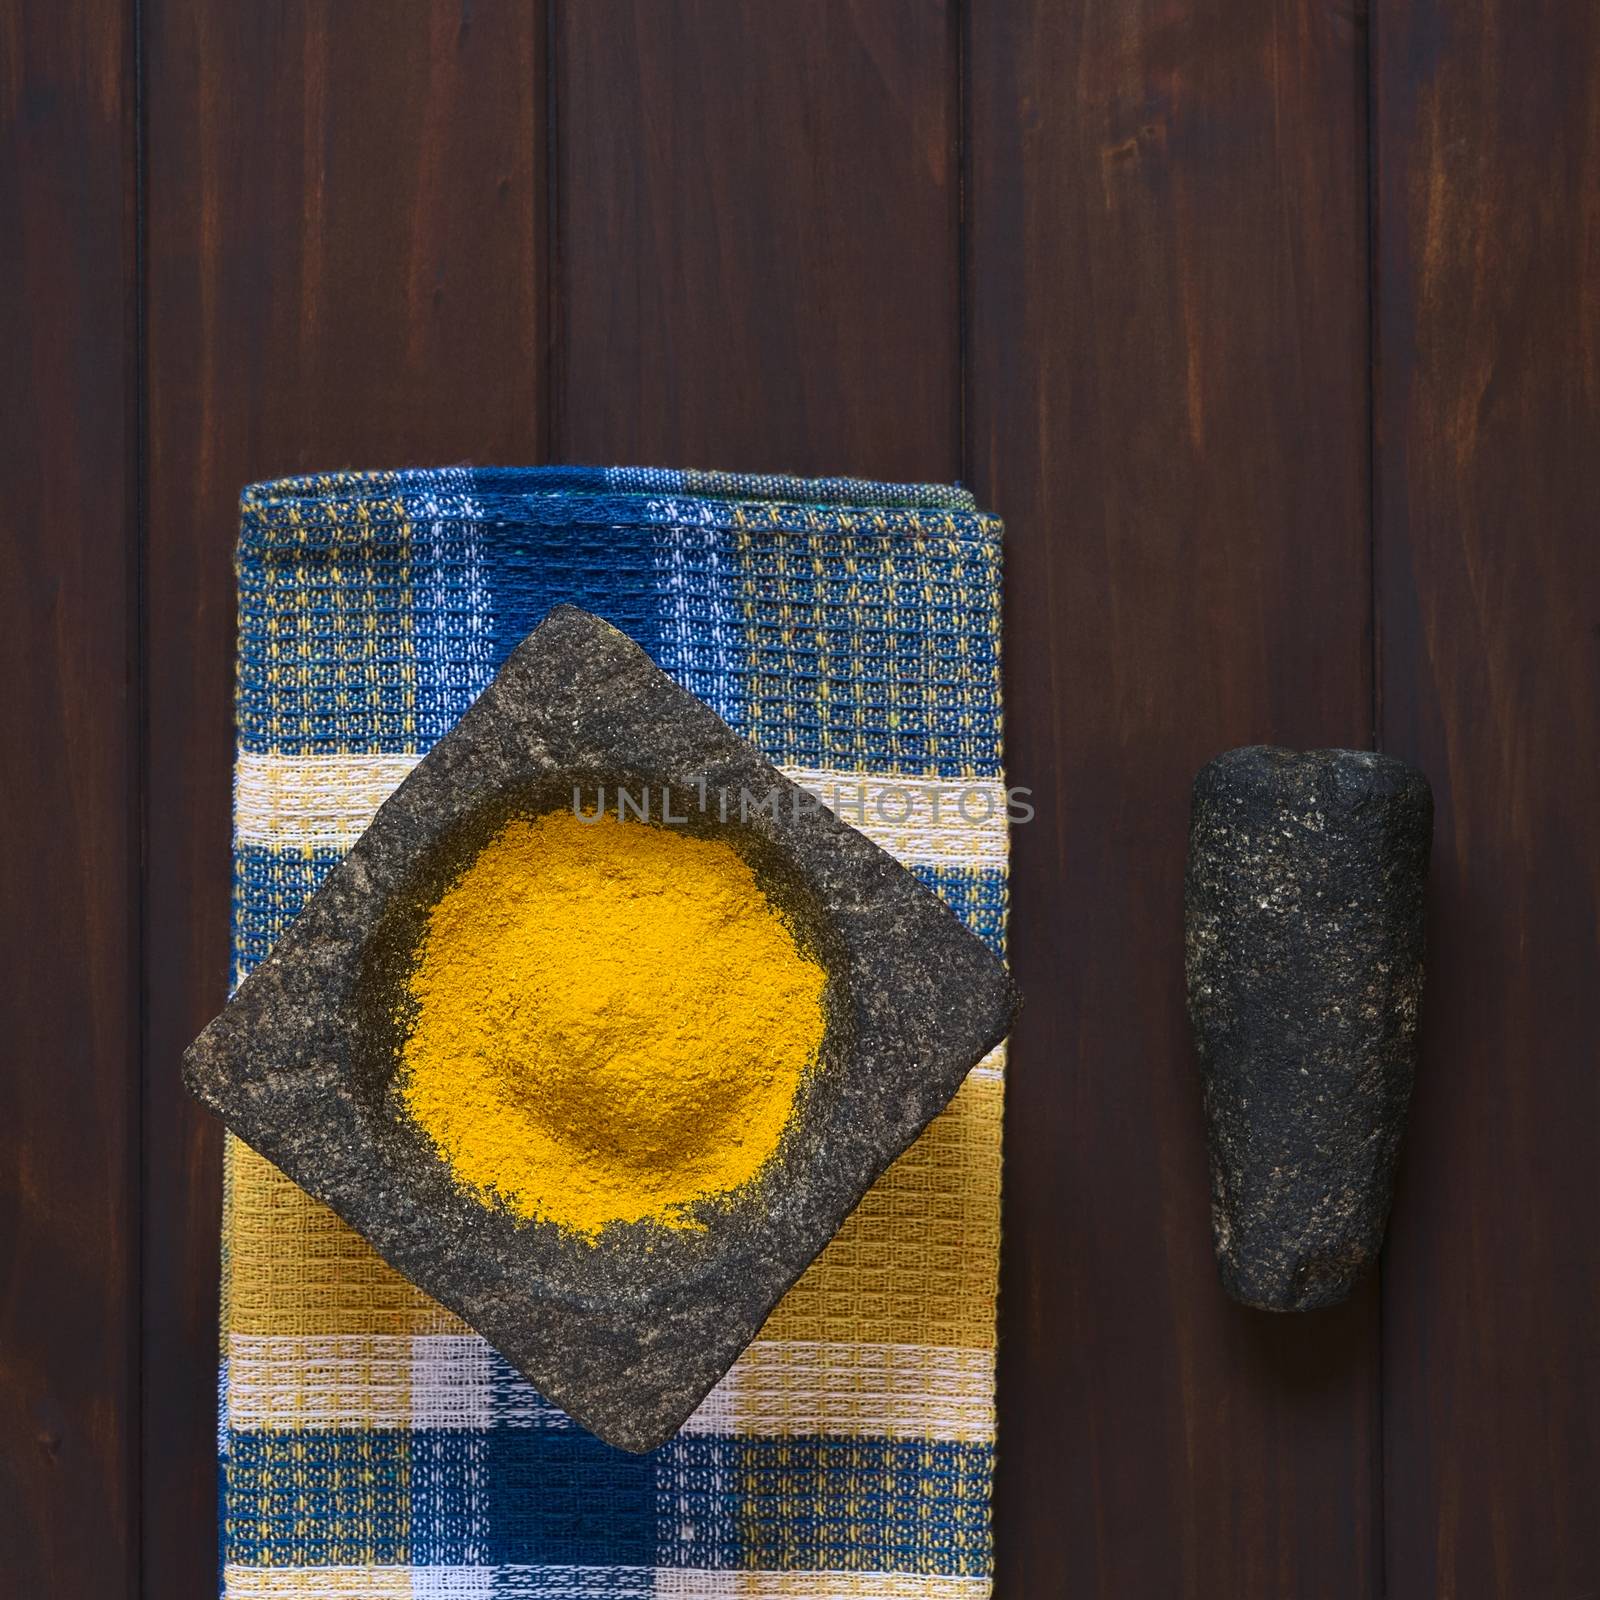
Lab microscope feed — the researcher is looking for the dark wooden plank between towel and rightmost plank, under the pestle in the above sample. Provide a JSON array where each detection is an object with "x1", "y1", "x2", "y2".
[{"x1": 968, "y1": 0, "x2": 1381, "y2": 1600}]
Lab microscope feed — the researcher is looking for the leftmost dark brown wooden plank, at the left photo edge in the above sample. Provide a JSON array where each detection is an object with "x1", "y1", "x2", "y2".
[{"x1": 0, "y1": 0, "x2": 139, "y2": 1600}]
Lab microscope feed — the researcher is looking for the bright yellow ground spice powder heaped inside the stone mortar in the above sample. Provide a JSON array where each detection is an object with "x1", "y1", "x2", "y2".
[{"x1": 400, "y1": 811, "x2": 824, "y2": 1242}]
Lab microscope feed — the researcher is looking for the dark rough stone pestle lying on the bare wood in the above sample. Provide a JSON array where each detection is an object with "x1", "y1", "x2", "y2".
[{"x1": 1184, "y1": 746, "x2": 1434, "y2": 1310}]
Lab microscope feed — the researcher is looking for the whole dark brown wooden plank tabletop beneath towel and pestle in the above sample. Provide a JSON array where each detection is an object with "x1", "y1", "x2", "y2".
[{"x1": 9, "y1": 0, "x2": 1600, "y2": 1600}]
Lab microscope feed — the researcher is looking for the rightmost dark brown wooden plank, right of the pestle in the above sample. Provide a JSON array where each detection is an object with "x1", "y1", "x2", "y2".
[{"x1": 1374, "y1": 0, "x2": 1600, "y2": 1600}]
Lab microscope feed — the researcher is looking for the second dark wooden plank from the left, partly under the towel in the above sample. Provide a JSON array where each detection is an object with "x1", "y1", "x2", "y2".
[{"x1": 144, "y1": 0, "x2": 546, "y2": 1595}]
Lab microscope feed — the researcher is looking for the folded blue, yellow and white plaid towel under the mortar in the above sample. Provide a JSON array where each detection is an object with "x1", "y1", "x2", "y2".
[{"x1": 221, "y1": 469, "x2": 1006, "y2": 1600}]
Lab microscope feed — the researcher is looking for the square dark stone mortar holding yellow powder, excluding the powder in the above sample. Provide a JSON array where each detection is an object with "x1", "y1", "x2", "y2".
[{"x1": 184, "y1": 606, "x2": 1018, "y2": 1451}]
